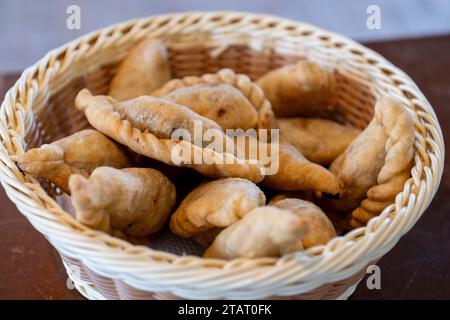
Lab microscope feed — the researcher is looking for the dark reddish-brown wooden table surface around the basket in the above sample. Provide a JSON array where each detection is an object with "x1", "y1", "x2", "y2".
[{"x1": 0, "y1": 36, "x2": 450, "y2": 299}]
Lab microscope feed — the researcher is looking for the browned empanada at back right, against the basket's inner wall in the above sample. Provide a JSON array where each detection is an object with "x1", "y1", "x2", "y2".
[{"x1": 257, "y1": 61, "x2": 335, "y2": 117}]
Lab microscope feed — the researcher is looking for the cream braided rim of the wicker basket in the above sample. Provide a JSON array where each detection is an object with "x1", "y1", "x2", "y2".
[{"x1": 0, "y1": 11, "x2": 445, "y2": 292}]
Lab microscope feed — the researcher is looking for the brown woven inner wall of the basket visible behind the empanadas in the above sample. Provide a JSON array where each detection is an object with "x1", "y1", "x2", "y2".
[{"x1": 25, "y1": 37, "x2": 377, "y2": 255}]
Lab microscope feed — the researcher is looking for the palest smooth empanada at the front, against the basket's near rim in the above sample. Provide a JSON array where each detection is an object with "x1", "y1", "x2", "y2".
[{"x1": 203, "y1": 206, "x2": 308, "y2": 260}]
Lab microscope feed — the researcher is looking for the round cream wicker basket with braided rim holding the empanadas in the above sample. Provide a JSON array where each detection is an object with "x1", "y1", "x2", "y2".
[{"x1": 0, "y1": 12, "x2": 444, "y2": 299}]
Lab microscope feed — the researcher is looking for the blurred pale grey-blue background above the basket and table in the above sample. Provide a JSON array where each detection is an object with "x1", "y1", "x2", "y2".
[{"x1": 0, "y1": 0, "x2": 450, "y2": 73}]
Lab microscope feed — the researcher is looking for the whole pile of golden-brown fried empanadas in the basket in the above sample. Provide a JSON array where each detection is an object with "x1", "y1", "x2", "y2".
[{"x1": 17, "y1": 38, "x2": 414, "y2": 259}]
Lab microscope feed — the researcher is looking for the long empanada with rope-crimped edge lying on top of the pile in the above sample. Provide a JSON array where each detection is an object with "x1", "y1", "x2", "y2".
[{"x1": 75, "y1": 89, "x2": 264, "y2": 182}]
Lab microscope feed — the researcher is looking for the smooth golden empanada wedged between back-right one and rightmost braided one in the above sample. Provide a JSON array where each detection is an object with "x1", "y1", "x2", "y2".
[{"x1": 278, "y1": 118, "x2": 361, "y2": 166}]
